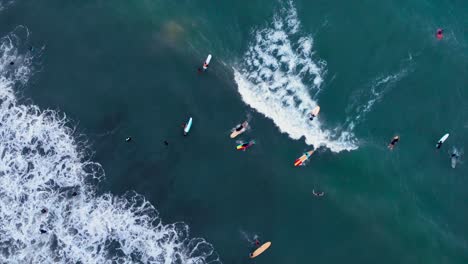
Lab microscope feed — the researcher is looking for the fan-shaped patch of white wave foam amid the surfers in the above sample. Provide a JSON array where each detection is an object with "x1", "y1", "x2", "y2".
[{"x1": 234, "y1": 2, "x2": 357, "y2": 152}]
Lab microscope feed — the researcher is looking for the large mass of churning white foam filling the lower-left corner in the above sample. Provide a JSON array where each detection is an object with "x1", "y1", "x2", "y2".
[{"x1": 0, "y1": 28, "x2": 220, "y2": 264}]
